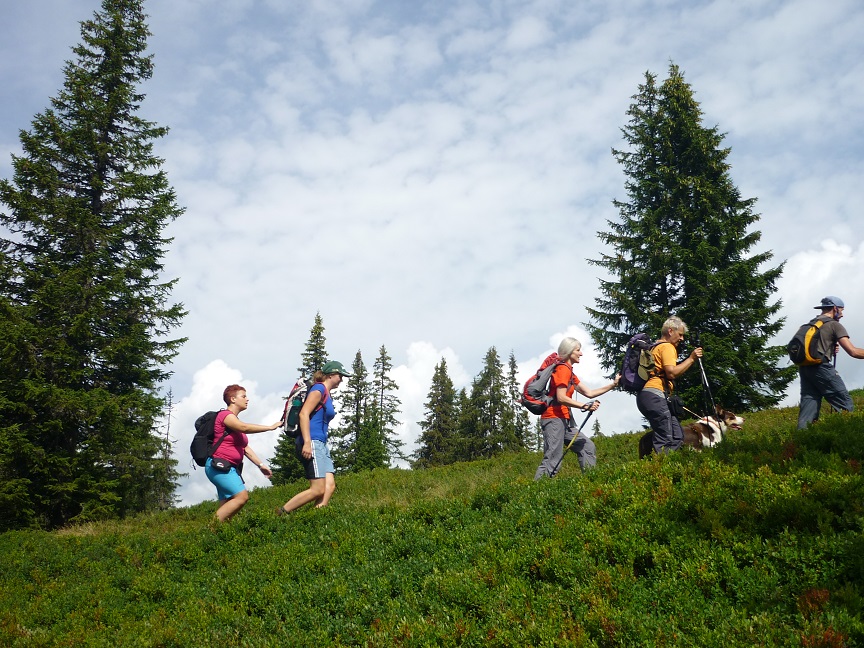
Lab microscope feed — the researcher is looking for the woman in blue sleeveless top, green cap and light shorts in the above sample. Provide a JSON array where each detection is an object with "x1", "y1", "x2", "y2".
[{"x1": 277, "y1": 360, "x2": 351, "y2": 515}]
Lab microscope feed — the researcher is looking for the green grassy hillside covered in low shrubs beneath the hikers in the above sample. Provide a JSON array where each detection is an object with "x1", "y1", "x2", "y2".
[{"x1": 0, "y1": 392, "x2": 864, "y2": 647}]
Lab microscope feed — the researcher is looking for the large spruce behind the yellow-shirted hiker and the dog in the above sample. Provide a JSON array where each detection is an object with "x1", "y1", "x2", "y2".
[{"x1": 587, "y1": 64, "x2": 794, "y2": 411}]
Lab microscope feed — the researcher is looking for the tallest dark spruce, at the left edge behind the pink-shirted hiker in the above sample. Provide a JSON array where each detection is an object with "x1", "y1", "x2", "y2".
[{"x1": 0, "y1": 0, "x2": 184, "y2": 528}]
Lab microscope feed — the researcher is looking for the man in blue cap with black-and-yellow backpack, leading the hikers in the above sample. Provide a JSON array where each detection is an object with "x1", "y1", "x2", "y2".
[{"x1": 798, "y1": 296, "x2": 864, "y2": 430}]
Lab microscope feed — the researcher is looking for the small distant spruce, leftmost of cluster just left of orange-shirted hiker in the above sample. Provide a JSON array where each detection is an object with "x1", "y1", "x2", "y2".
[{"x1": 411, "y1": 358, "x2": 459, "y2": 468}]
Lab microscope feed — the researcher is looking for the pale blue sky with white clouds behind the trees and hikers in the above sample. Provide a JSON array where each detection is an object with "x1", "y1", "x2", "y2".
[{"x1": 0, "y1": 0, "x2": 864, "y2": 503}]
